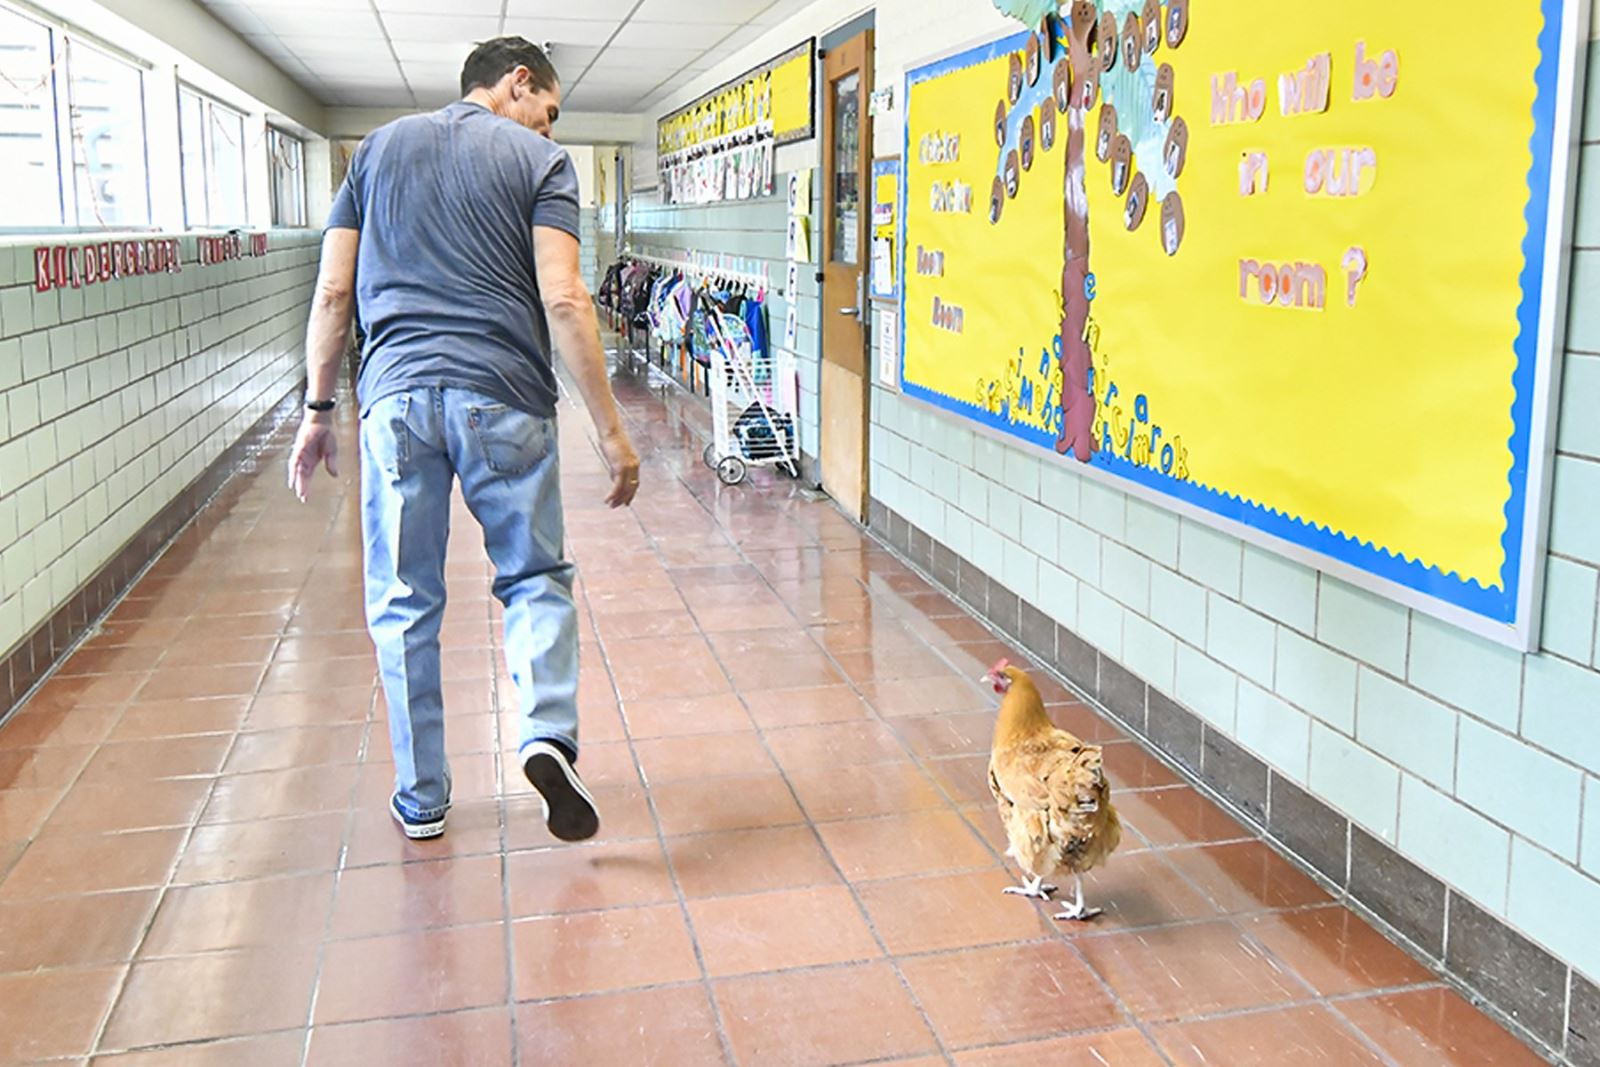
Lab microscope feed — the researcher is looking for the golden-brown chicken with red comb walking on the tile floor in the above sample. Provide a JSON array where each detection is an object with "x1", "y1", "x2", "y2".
[{"x1": 984, "y1": 659, "x2": 1122, "y2": 920}]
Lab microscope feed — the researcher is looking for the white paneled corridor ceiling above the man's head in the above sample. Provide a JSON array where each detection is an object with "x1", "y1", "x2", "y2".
[{"x1": 202, "y1": 0, "x2": 808, "y2": 112}]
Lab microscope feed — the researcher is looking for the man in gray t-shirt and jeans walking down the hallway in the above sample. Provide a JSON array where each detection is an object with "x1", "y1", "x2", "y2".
[{"x1": 290, "y1": 37, "x2": 638, "y2": 841}]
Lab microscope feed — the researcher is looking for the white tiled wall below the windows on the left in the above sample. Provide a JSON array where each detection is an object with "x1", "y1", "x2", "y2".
[{"x1": 0, "y1": 232, "x2": 317, "y2": 653}]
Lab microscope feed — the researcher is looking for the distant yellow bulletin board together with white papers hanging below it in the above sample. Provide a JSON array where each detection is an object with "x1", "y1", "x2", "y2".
[{"x1": 656, "y1": 38, "x2": 816, "y2": 203}]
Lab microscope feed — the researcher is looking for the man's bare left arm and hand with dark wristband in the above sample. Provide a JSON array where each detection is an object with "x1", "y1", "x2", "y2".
[{"x1": 290, "y1": 229, "x2": 362, "y2": 502}]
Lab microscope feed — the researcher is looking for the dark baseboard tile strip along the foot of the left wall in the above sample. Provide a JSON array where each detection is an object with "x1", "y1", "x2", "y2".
[{"x1": 0, "y1": 384, "x2": 304, "y2": 721}]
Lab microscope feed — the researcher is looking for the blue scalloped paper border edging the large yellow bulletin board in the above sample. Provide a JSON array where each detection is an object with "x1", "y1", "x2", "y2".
[{"x1": 899, "y1": 0, "x2": 1568, "y2": 624}]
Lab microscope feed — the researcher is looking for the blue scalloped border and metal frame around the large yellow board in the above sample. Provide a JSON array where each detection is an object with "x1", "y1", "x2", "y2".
[{"x1": 896, "y1": 0, "x2": 1590, "y2": 651}]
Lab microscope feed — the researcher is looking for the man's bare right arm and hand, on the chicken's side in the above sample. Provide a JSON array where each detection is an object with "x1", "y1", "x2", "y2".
[{"x1": 533, "y1": 226, "x2": 638, "y2": 507}]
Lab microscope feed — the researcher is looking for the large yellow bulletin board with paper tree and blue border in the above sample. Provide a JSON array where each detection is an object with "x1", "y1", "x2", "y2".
[{"x1": 899, "y1": 0, "x2": 1589, "y2": 648}]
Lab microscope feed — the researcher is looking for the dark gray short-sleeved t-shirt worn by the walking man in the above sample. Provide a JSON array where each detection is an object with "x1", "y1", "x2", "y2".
[{"x1": 328, "y1": 101, "x2": 578, "y2": 416}]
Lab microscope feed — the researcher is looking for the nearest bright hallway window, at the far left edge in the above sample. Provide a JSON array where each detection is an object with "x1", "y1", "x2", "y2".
[{"x1": 0, "y1": 6, "x2": 150, "y2": 229}]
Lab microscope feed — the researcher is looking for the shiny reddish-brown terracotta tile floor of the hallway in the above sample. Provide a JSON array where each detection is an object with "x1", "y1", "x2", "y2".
[{"x1": 0, "y1": 361, "x2": 1538, "y2": 1067}]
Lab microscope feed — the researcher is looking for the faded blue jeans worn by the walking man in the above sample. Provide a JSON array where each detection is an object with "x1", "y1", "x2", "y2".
[{"x1": 362, "y1": 389, "x2": 578, "y2": 819}]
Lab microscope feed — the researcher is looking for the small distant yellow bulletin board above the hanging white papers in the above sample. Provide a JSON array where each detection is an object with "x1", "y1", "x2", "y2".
[{"x1": 656, "y1": 37, "x2": 816, "y2": 157}]
